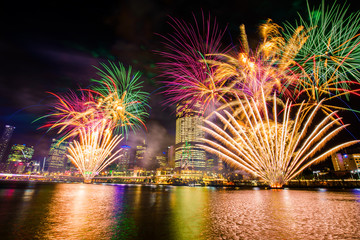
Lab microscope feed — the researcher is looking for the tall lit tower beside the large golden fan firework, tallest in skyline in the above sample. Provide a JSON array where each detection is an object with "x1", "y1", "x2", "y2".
[{"x1": 175, "y1": 103, "x2": 206, "y2": 170}]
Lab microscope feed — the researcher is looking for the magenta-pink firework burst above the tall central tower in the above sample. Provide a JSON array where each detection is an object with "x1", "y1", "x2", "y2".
[{"x1": 159, "y1": 15, "x2": 231, "y2": 111}]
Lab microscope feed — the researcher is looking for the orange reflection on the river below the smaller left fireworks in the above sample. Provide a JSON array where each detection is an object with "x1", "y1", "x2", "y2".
[{"x1": 39, "y1": 184, "x2": 116, "y2": 239}]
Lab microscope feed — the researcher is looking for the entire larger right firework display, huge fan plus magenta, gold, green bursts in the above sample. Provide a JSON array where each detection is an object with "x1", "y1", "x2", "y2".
[{"x1": 156, "y1": 2, "x2": 360, "y2": 187}]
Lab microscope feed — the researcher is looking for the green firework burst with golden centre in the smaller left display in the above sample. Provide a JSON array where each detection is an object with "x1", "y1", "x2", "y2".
[{"x1": 92, "y1": 62, "x2": 149, "y2": 137}]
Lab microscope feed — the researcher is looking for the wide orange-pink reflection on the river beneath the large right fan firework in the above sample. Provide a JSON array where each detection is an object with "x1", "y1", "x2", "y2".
[{"x1": 205, "y1": 190, "x2": 360, "y2": 239}]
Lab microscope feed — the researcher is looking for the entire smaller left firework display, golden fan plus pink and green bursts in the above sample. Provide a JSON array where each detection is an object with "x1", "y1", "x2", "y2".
[{"x1": 43, "y1": 62, "x2": 148, "y2": 182}]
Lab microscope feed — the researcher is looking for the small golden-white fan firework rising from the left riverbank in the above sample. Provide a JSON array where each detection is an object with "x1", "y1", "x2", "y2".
[{"x1": 67, "y1": 121, "x2": 122, "y2": 182}]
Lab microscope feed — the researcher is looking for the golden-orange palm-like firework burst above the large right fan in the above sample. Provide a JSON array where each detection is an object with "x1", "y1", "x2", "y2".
[{"x1": 206, "y1": 20, "x2": 306, "y2": 109}]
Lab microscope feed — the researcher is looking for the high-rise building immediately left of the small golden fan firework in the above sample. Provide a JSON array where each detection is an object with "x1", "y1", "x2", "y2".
[{"x1": 45, "y1": 139, "x2": 69, "y2": 172}]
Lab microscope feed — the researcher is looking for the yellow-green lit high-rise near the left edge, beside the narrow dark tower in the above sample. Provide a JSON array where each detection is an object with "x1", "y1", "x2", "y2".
[{"x1": 7, "y1": 144, "x2": 34, "y2": 173}]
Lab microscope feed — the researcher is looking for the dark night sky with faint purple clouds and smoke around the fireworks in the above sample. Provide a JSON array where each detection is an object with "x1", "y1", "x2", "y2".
[{"x1": 0, "y1": 0, "x2": 360, "y2": 160}]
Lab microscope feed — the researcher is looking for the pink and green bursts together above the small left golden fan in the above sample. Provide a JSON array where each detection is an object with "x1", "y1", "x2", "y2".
[{"x1": 42, "y1": 62, "x2": 148, "y2": 140}]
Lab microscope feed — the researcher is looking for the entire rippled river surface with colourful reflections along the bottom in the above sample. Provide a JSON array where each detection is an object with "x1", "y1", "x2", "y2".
[{"x1": 0, "y1": 183, "x2": 360, "y2": 240}]
